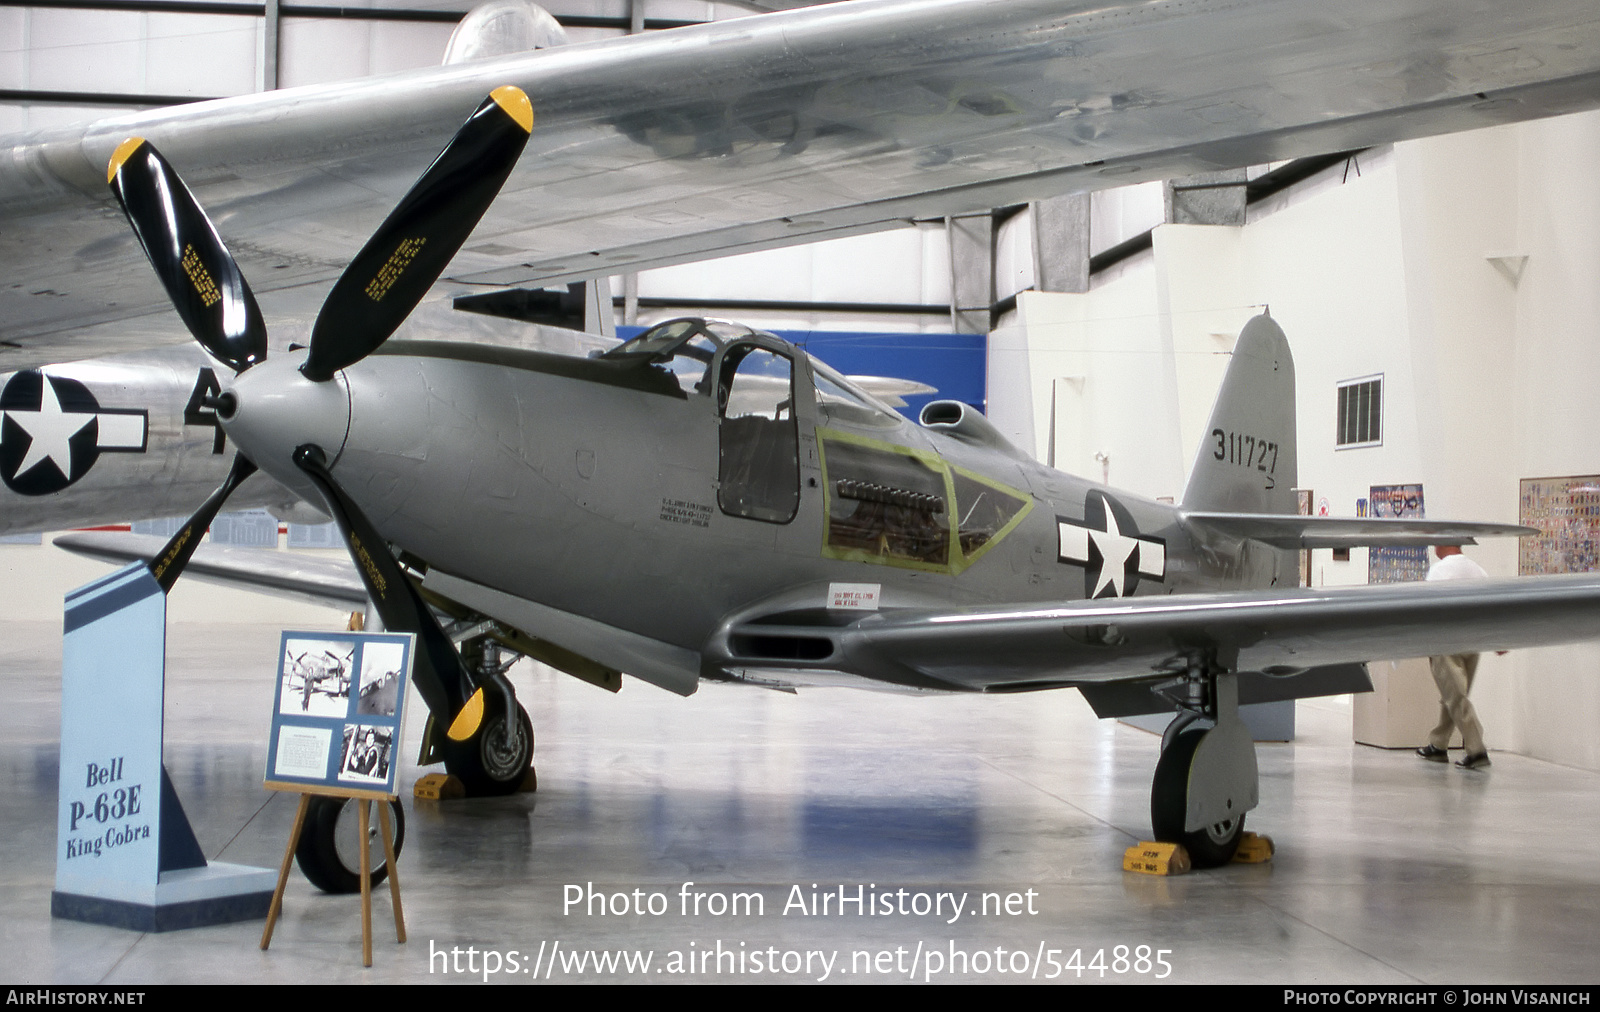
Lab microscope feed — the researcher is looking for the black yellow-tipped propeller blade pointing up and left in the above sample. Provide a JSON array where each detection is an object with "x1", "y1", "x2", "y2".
[{"x1": 106, "y1": 138, "x2": 267, "y2": 373}]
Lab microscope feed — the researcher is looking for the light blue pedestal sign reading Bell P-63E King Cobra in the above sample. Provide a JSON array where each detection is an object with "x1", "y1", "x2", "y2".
[{"x1": 50, "y1": 564, "x2": 274, "y2": 932}]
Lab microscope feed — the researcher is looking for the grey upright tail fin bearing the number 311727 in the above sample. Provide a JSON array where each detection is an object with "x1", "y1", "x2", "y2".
[{"x1": 1184, "y1": 314, "x2": 1298, "y2": 514}]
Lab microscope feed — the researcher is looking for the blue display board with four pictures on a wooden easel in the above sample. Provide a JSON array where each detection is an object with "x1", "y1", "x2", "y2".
[{"x1": 266, "y1": 633, "x2": 416, "y2": 794}]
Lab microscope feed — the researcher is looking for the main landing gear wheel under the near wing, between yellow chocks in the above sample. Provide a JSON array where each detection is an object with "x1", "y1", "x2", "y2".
[{"x1": 1150, "y1": 653, "x2": 1261, "y2": 868}]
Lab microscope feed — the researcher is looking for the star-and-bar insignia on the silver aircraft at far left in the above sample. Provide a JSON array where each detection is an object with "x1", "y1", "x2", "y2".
[{"x1": 0, "y1": 368, "x2": 150, "y2": 495}]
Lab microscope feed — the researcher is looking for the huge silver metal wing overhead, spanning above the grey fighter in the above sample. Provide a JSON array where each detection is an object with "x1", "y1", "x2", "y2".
[{"x1": 9, "y1": 0, "x2": 1600, "y2": 368}]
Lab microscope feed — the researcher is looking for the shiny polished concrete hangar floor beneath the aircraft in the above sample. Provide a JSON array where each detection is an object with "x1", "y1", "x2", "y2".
[{"x1": 0, "y1": 621, "x2": 1600, "y2": 985}]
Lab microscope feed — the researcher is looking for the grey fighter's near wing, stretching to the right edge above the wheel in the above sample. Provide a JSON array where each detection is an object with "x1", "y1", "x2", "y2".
[{"x1": 806, "y1": 573, "x2": 1600, "y2": 692}]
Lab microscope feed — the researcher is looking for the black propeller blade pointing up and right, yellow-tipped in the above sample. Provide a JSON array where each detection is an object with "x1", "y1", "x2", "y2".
[{"x1": 301, "y1": 85, "x2": 533, "y2": 383}]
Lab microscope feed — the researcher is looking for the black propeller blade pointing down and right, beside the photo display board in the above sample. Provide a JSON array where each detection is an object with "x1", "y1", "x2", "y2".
[{"x1": 294, "y1": 444, "x2": 474, "y2": 714}]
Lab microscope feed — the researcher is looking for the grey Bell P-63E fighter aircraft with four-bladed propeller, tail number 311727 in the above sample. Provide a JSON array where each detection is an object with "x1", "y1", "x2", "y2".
[{"x1": 62, "y1": 86, "x2": 1600, "y2": 881}]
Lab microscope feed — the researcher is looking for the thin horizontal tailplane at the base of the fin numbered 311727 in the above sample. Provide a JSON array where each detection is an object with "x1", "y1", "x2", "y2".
[{"x1": 1184, "y1": 511, "x2": 1539, "y2": 548}]
